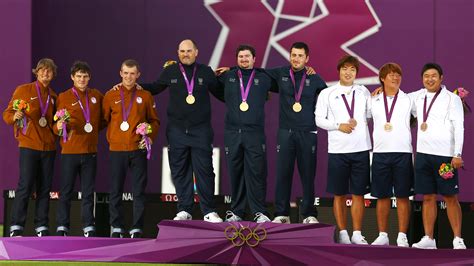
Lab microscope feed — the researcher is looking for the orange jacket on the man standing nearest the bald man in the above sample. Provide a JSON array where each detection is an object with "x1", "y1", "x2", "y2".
[{"x1": 102, "y1": 87, "x2": 160, "y2": 151}]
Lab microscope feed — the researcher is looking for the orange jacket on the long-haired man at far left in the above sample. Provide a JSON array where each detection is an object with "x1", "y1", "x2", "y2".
[{"x1": 3, "y1": 82, "x2": 57, "y2": 151}]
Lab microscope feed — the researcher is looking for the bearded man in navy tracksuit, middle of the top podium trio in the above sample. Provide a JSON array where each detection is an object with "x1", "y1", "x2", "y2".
[{"x1": 219, "y1": 45, "x2": 276, "y2": 222}]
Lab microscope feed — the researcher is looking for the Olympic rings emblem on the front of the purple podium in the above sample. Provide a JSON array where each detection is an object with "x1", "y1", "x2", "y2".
[{"x1": 224, "y1": 225, "x2": 267, "y2": 248}]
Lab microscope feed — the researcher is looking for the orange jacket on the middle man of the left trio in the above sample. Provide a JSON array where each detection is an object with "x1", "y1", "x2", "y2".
[{"x1": 53, "y1": 88, "x2": 106, "y2": 154}]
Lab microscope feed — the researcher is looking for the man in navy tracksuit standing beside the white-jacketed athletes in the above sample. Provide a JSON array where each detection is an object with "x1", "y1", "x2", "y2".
[{"x1": 267, "y1": 42, "x2": 327, "y2": 223}]
